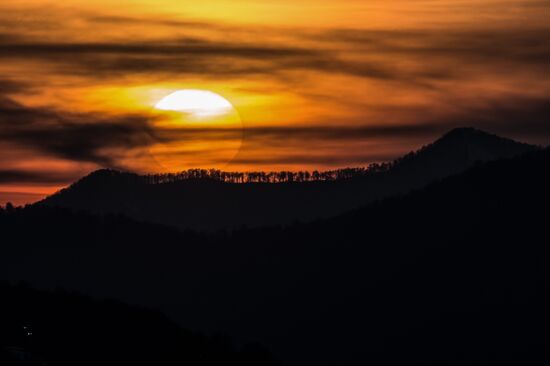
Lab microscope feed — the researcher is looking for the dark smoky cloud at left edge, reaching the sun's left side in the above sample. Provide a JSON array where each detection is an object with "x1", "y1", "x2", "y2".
[{"x1": 0, "y1": 97, "x2": 156, "y2": 167}]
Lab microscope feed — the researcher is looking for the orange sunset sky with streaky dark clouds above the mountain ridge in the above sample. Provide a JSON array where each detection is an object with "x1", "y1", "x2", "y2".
[{"x1": 0, "y1": 0, "x2": 550, "y2": 204}]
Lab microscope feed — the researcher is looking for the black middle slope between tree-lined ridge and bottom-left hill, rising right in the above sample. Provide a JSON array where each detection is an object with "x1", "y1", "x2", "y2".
[{"x1": 0, "y1": 149, "x2": 550, "y2": 365}]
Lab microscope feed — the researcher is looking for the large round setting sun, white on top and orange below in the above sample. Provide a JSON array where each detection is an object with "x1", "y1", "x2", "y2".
[{"x1": 149, "y1": 89, "x2": 243, "y2": 172}]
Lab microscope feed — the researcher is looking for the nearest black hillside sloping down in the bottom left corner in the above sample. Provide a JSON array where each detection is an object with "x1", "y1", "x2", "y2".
[{"x1": 0, "y1": 283, "x2": 274, "y2": 366}]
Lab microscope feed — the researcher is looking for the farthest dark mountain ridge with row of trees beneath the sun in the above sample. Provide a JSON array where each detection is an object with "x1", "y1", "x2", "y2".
[{"x1": 40, "y1": 128, "x2": 536, "y2": 230}]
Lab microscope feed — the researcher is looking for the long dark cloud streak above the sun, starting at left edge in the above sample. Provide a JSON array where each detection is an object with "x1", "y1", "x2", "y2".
[{"x1": 0, "y1": 35, "x2": 326, "y2": 76}]
